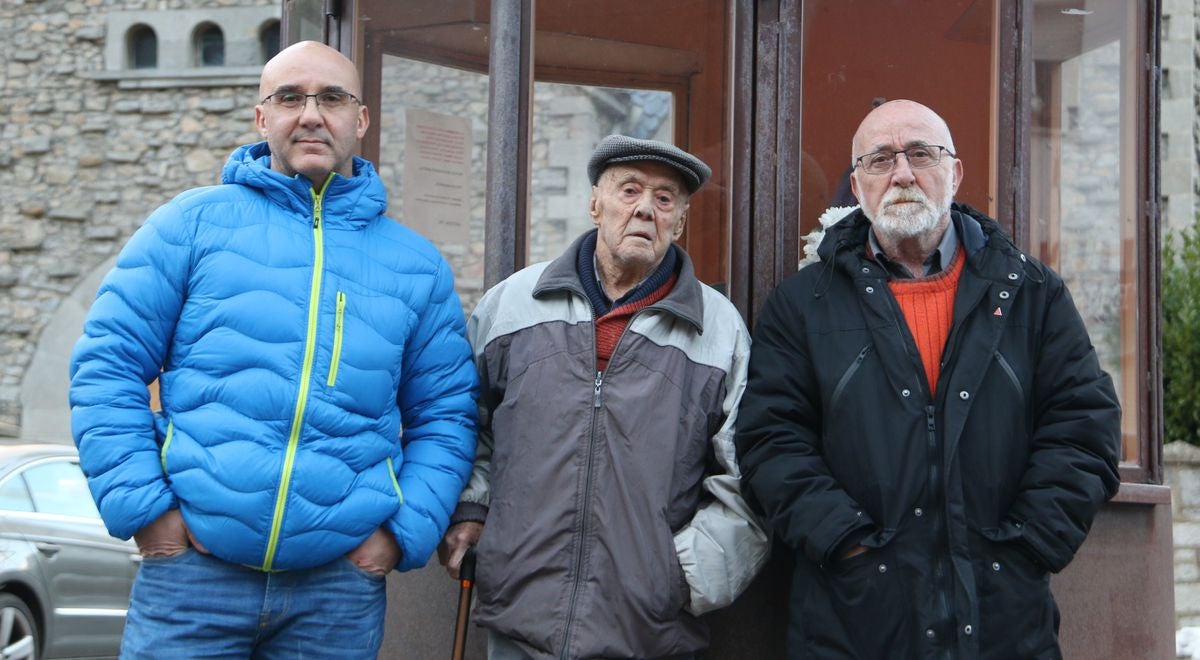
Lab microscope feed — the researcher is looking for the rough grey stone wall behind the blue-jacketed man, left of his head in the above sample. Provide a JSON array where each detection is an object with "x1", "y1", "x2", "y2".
[{"x1": 0, "y1": 0, "x2": 280, "y2": 438}]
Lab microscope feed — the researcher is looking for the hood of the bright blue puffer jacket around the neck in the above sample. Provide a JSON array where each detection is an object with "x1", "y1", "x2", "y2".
[{"x1": 221, "y1": 142, "x2": 388, "y2": 229}]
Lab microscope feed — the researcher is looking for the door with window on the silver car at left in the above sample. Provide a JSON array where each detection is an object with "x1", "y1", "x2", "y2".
[{"x1": 22, "y1": 457, "x2": 140, "y2": 656}]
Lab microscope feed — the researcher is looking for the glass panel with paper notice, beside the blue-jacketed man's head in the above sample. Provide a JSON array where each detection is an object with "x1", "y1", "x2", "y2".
[{"x1": 362, "y1": 0, "x2": 488, "y2": 314}]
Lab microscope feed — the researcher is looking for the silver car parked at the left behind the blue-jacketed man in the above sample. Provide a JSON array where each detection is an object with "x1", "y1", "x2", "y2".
[{"x1": 0, "y1": 444, "x2": 142, "y2": 659}]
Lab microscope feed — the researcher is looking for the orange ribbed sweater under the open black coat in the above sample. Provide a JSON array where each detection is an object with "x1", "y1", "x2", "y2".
[{"x1": 888, "y1": 254, "x2": 964, "y2": 396}]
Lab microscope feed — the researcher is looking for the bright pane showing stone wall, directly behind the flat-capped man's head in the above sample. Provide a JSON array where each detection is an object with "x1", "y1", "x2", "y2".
[{"x1": 528, "y1": 83, "x2": 674, "y2": 263}]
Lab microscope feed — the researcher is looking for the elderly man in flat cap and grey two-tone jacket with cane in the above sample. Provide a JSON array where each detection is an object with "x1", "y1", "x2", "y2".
[{"x1": 439, "y1": 136, "x2": 768, "y2": 660}]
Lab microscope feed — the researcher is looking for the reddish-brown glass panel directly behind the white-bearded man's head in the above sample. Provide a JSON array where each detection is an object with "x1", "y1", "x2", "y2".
[{"x1": 799, "y1": 0, "x2": 996, "y2": 243}]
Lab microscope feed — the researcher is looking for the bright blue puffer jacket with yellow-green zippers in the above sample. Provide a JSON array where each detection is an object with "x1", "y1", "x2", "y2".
[{"x1": 71, "y1": 143, "x2": 476, "y2": 570}]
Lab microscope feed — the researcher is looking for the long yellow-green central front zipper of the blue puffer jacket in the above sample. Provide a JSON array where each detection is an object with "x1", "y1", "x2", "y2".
[{"x1": 263, "y1": 173, "x2": 334, "y2": 571}]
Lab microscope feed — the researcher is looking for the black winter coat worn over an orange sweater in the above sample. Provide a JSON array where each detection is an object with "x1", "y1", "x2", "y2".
[{"x1": 737, "y1": 205, "x2": 1121, "y2": 660}]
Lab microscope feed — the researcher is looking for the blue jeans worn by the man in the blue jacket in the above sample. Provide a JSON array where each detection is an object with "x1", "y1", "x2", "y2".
[{"x1": 121, "y1": 548, "x2": 386, "y2": 659}]
